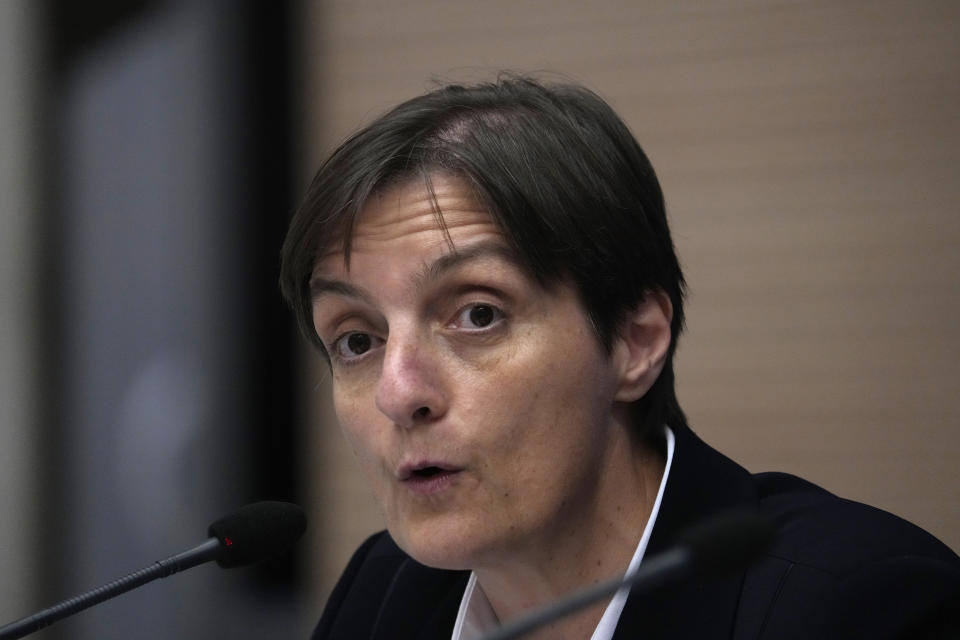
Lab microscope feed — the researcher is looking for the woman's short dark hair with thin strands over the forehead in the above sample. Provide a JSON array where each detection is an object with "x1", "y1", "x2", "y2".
[{"x1": 280, "y1": 76, "x2": 686, "y2": 438}]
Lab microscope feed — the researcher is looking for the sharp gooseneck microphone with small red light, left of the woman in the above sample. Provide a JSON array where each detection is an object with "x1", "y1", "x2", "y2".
[{"x1": 0, "y1": 502, "x2": 307, "y2": 640}]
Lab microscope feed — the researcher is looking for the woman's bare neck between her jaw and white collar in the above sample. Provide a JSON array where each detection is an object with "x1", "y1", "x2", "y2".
[{"x1": 475, "y1": 429, "x2": 665, "y2": 638}]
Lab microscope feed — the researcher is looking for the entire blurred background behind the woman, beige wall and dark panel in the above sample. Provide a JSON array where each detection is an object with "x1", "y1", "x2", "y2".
[{"x1": 0, "y1": 0, "x2": 960, "y2": 639}]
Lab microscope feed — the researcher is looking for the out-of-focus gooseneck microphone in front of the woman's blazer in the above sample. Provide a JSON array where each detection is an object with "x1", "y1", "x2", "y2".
[{"x1": 482, "y1": 511, "x2": 776, "y2": 640}]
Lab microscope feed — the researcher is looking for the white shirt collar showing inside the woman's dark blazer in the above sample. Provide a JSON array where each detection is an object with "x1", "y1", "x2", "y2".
[{"x1": 451, "y1": 425, "x2": 676, "y2": 640}]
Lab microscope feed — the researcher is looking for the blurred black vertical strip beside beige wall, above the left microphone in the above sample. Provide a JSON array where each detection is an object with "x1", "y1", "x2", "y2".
[{"x1": 240, "y1": 2, "x2": 299, "y2": 536}]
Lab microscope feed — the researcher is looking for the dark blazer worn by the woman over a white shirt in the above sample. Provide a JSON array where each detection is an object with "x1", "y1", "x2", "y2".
[{"x1": 313, "y1": 428, "x2": 960, "y2": 640}]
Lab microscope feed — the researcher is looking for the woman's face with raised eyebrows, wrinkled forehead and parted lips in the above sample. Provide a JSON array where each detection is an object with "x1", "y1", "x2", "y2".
[{"x1": 311, "y1": 176, "x2": 617, "y2": 568}]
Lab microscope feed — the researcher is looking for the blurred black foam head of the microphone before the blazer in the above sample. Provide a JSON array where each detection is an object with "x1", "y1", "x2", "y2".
[{"x1": 678, "y1": 510, "x2": 776, "y2": 573}]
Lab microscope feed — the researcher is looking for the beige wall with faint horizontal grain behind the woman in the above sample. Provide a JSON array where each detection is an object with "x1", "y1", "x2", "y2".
[{"x1": 301, "y1": 0, "x2": 960, "y2": 610}]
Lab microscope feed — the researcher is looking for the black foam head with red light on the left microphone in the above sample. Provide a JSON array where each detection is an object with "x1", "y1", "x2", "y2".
[{"x1": 207, "y1": 501, "x2": 307, "y2": 568}]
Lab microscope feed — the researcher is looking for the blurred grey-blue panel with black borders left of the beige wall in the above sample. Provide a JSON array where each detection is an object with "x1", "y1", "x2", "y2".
[{"x1": 41, "y1": 0, "x2": 303, "y2": 639}]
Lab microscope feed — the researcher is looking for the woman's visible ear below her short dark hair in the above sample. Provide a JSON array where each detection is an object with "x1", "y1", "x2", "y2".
[{"x1": 613, "y1": 289, "x2": 673, "y2": 402}]
